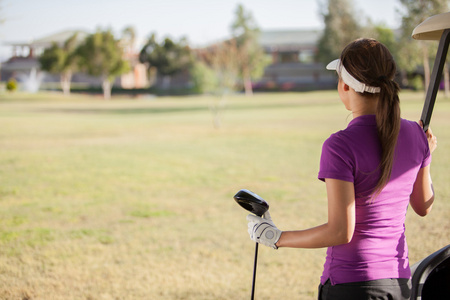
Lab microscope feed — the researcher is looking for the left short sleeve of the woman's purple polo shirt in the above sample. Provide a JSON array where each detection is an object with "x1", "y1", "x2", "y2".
[{"x1": 318, "y1": 134, "x2": 355, "y2": 182}]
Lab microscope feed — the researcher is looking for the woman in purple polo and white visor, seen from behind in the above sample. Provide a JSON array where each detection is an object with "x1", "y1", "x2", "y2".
[{"x1": 247, "y1": 39, "x2": 437, "y2": 300}]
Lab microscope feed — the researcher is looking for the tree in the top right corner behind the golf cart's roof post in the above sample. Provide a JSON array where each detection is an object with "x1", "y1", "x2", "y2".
[{"x1": 398, "y1": 0, "x2": 449, "y2": 89}]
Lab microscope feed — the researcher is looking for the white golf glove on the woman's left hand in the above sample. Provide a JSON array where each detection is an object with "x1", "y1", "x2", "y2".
[{"x1": 247, "y1": 211, "x2": 281, "y2": 249}]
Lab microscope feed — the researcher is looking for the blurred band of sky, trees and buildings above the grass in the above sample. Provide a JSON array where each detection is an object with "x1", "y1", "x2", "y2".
[{"x1": 0, "y1": 0, "x2": 449, "y2": 98}]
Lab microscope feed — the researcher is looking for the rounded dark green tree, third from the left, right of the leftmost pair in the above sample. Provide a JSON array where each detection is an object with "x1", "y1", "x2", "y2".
[{"x1": 139, "y1": 34, "x2": 193, "y2": 88}]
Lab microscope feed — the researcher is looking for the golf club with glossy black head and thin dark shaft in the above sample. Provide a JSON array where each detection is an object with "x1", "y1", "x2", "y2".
[{"x1": 234, "y1": 189, "x2": 269, "y2": 300}]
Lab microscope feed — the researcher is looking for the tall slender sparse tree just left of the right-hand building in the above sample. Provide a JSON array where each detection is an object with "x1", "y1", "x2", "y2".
[{"x1": 231, "y1": 5, "x2": 268, "y2": 95}]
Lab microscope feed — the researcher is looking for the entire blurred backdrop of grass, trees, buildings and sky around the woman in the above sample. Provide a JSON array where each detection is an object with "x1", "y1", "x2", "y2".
[{"x1": 0, "y1": 0, "x2": 450, "y2": 300}]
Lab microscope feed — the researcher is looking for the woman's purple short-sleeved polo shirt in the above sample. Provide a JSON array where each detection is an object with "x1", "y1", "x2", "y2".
[{"x1": 318, "y1": 115, "x2": 431, "y2": 285}]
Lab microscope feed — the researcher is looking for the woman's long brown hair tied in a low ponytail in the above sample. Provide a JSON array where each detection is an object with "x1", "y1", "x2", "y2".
[{"x1": 341, "y1": 39, "x2": 400, "y2": 194}]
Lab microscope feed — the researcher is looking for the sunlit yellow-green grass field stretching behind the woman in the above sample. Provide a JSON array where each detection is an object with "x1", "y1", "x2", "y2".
[{"x1": 0, "y1": 92, "x2": 450, "y2": 299}]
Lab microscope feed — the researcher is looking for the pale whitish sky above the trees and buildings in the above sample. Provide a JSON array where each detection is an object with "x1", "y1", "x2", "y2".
[{"x1": 0, "y1": 0, "x2": 400, "y2": 61}]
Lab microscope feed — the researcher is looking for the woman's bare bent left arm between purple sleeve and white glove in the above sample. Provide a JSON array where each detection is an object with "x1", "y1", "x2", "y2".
[{"x1": 276, "y1": 178, "x2": 355, "y2": 248}]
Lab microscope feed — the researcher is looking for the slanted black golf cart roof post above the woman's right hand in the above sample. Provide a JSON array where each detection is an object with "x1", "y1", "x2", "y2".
[{"x1": 420, "y1": 29, "x2": 450, "y2": 132}]
